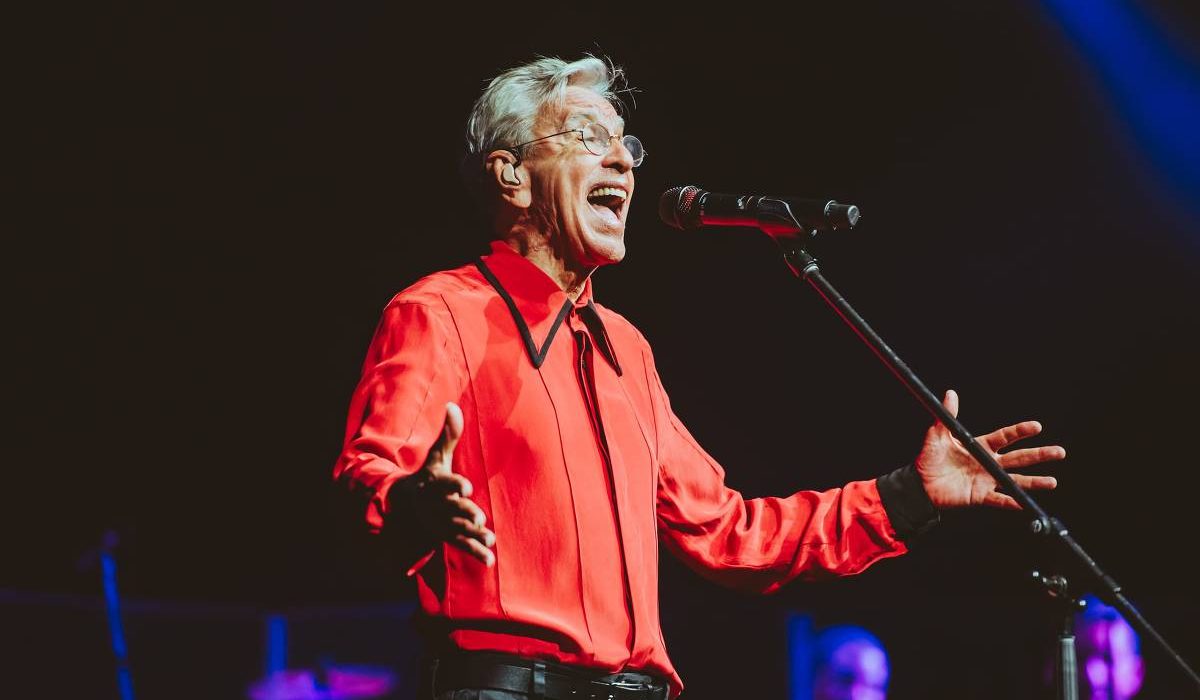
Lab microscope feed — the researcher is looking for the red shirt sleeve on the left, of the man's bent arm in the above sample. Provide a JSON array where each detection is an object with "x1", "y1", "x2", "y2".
[{"x1": 334, "y1": 300, "x2": 463, "y2": 573}]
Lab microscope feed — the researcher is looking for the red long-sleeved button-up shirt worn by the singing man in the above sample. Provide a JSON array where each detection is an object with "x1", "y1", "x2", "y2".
[{"x1": 334, "y1": 241, "x2": 906, "y2": 694}]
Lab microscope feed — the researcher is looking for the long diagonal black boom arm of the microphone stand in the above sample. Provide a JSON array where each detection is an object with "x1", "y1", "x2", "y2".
[{"x1": 761, "y1": 236, "x2": 1200, "y2": 690}]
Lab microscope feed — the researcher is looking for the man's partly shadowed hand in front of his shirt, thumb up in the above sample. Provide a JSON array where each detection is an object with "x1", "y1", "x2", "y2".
[{"x1": 409, "y1": 402, "x2": 496, "y2": 567}]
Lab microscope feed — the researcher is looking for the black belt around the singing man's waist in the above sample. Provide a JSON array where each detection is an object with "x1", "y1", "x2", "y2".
[{"x1": 430, "y1": 653, "x2": 667, "y2": 700}]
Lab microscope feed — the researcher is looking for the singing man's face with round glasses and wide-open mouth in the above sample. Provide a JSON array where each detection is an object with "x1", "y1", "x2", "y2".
[{"x1": 523, "y1": 86, "x2": 634, "y2": 269}]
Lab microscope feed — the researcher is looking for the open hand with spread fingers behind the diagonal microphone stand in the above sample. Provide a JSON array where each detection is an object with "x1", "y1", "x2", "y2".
[{"x1": 917, "y1": 389, "x2": 1067, "y2": 510}]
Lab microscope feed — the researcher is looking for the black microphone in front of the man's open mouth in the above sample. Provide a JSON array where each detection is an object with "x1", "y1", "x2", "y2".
[{"x1": 659, "y1": 185, "x2": 862, "y2": 238}]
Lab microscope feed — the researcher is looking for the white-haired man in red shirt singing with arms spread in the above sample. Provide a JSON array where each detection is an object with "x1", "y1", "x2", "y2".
[{"x1": 335, "y1": 56, "x2": 1064, "y2": 700}]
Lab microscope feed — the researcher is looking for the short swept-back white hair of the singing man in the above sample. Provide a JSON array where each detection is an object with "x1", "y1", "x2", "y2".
[{"x1": 467, "y1": 54, "x2": 624, "y2": 161}]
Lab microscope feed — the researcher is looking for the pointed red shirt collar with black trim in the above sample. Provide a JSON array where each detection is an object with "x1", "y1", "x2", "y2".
[{"x1": 475, "y1": 240, "x2": 620, "y2": 375}]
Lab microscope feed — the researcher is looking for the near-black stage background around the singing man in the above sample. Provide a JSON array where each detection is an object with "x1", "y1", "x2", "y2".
[{"x1": 11, "y1": 1, "x2": 1200, "y2": 700}]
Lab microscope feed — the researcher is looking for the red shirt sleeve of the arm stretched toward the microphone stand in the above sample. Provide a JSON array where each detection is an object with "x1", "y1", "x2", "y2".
[{"x1": 646, "y1": 352, "x2": 907, "y2": 593}]
